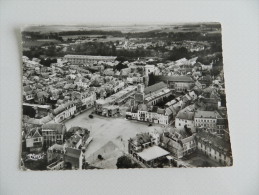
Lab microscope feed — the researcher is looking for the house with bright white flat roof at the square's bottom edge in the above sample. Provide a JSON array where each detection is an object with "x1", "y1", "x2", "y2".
[{"x1": 128, "y1": 133, "x2": 169, "y2": 167}]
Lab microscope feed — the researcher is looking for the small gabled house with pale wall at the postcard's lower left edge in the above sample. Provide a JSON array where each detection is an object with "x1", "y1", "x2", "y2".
[{"x1": 25, "y1": 127, "x2": 43, "y2": 152}]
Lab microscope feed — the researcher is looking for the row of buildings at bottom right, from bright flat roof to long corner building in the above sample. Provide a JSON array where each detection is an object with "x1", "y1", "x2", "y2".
[{"x1": 128, "y1": 128, "x2": 233, "y2": 167}]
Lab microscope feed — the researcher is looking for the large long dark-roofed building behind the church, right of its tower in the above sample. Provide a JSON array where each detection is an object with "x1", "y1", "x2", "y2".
[{"x1": 155, "y1": 76, "x2": 194, "y2": 92}]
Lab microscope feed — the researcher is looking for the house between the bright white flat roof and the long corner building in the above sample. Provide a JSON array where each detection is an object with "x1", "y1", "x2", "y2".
[{"x1": 161, "y1": 129, "x2": 196, "y2": 158}]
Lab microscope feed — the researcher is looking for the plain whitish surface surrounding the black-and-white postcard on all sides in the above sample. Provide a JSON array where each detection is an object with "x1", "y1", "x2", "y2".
[{"x1": 0, "y1": 0, "x2": 259, "y2": 195}]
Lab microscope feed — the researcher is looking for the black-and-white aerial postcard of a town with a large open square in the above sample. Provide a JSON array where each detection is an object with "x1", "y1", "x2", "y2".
[{"x1": 19, "y1": 22, "x2": 233, "y2": 171}]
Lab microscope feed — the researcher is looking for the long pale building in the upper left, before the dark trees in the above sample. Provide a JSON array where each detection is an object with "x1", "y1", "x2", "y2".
[{"x1": 63, "y1": 55, "x2": 117, "y2": 64}]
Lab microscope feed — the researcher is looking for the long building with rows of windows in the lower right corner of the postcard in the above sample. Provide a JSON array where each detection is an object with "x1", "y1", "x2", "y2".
[{"x1": 196, "y1": 129, "x2": 233, "y2": 166}]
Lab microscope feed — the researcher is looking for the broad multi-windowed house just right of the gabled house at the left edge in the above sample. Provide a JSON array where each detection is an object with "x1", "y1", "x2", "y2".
[{"x1": 42, "y1": 123, "x2": 66, "y2": 147}]
